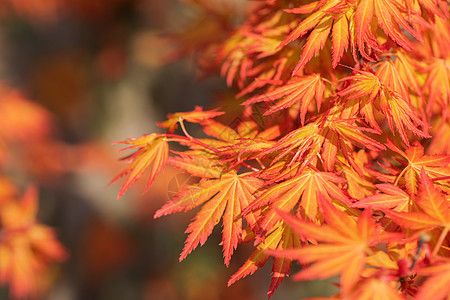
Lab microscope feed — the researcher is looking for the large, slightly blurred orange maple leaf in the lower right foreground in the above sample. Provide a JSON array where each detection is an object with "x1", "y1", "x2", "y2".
[{"x1": 267, "y1": 198, "x2": 398, "y2": 295}]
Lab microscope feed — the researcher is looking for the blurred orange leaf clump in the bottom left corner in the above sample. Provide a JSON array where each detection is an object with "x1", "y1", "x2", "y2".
[{"x1": 0, "y1": 184, "x2": 67, "y2": 298}]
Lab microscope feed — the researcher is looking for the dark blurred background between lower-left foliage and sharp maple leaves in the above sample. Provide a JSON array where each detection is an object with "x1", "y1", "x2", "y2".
[{"x1": 0, "y1": 0, "x2": 332, "y2": 300}]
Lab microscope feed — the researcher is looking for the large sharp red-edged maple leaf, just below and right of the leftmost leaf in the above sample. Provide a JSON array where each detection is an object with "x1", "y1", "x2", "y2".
[{"x1": 155, "y1": 171, "x2": 262, "y2": 266}]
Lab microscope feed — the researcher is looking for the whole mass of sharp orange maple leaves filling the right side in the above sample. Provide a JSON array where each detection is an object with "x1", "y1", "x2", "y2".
[{"x1": 112, "y1": 0, "x2": 450, "y2": 299}]
